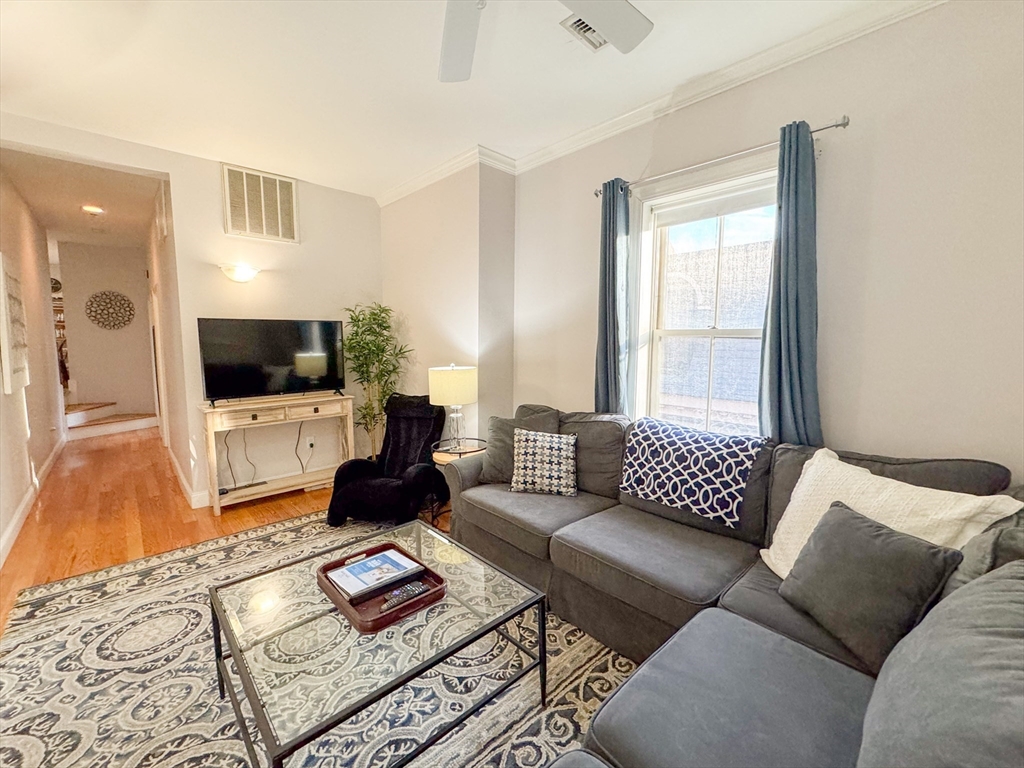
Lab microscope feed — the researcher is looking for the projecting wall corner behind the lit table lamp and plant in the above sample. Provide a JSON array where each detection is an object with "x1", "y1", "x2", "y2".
[{"x1": 381, "y1": 163, "x2": 515, "y2": 437}]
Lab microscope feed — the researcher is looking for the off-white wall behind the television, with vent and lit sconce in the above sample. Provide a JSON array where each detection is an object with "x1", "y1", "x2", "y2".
[{"x1": 0, "y1": 114, "x2": 382, "y2": 505}]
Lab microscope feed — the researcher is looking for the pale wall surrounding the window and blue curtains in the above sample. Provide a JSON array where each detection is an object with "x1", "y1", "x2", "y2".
[{"x1": 515, "y1": 1, "x2": 1024, "y2": 482}]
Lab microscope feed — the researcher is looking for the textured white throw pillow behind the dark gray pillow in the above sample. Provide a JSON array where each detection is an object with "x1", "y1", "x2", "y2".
[{"x1": 761, "y1": 449, "x2": 1021, "y2": 579}]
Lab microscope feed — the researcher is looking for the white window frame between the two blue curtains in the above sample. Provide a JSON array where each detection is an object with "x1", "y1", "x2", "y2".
[{"x1": 630, "y1": 151, "x2": 778, "y2": 428}]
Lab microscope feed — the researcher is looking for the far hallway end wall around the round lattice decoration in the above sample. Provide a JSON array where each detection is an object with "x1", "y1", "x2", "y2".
[{"x1": 57, "y1": 243, "x2": 156, "y2": 414}]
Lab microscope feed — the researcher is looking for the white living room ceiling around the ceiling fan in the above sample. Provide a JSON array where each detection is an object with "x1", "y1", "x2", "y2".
[{"x1": 0, "y1": 0, "x2": 921, "y2": 202}]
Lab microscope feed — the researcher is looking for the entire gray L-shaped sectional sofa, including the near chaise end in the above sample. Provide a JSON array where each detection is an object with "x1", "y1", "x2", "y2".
[{"x1": 445, "y1": 406, "x2": 1024, "y2": 768}]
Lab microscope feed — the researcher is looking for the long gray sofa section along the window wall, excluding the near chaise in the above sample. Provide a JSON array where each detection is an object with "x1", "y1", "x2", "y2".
[{"x1": 444, "y1": 406, "x2": 1010, "y2": 671}]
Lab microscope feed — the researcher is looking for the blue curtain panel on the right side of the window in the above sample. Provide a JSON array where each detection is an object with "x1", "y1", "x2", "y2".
[{"x1": 759, "y1": 122, "x2": 824, "y2": 445}]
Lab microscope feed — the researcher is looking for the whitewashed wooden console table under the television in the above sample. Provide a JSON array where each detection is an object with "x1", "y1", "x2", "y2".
[{"x1": 200, "y1": 393, "x2": 355, "y2": 515}]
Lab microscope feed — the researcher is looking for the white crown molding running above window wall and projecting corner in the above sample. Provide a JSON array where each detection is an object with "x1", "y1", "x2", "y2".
[{"x1": 377, "y1": 0, "x2": 948, "y2": 208}]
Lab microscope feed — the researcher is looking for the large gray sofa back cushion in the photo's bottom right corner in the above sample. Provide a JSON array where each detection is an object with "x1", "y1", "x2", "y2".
[{"x1": 857, "y1": 560, "x2": 1024, "y2": 768}]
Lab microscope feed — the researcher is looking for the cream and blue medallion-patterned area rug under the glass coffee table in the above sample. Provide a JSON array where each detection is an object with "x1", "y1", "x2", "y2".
[{"x1": 0, "y1": 513, "x2": 634, "y2": 768}]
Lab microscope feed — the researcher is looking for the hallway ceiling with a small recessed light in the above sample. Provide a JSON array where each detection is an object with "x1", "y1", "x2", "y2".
[{"x1": 0, "y1": 150, "x2": 160, "y2": 246}]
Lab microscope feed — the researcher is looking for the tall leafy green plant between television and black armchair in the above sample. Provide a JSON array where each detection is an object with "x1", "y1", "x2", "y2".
[{"x1": 344, "y1": 302, "x2": 413, "y2": 461}]
